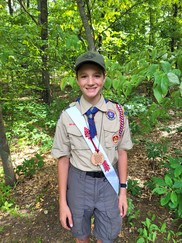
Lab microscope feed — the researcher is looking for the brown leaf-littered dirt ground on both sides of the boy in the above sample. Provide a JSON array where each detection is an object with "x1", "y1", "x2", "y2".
[{"x1": 0, "y1": 118, "x2": 181, "y2": 243}]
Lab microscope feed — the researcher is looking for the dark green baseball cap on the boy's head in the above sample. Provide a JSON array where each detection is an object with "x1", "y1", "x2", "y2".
[{"x1": 75, "y1": 51, "x2": 106, "y2": 71}]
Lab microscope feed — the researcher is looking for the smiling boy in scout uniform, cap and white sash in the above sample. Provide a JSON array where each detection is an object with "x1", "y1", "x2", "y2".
[{"x1": 52, "y1": 52, "x2": 132, "y2": 243}]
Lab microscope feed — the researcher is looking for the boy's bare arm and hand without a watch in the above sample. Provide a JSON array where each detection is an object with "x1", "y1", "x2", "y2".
[{"x1": 58, "y1": 156, "x2": 73, "y2": 230}]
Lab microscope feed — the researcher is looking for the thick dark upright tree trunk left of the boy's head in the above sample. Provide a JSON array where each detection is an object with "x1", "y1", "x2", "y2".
[{"x1": 38, "y1": 0, "x2": 51, "y2": 104}]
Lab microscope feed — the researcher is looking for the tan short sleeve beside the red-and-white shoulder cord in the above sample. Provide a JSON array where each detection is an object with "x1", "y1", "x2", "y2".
[{"x1": 118, "y1": 116, "x2": 133, "y2": 150}]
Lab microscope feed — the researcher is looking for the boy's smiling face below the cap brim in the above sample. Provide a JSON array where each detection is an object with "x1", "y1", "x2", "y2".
[{"x1": 77, "y1": 63, "x2": 106, "y2": 104}]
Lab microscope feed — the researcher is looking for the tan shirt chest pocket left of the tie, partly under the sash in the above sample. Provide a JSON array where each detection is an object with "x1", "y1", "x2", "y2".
[{"x1": 68, "y1": 126, "x2": 88, "y2": 150}]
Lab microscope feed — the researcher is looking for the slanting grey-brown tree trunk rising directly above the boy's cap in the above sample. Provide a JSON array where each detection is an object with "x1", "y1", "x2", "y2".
[{"x1": 76, "y1": 0, "x2": 95, "y2": 51}]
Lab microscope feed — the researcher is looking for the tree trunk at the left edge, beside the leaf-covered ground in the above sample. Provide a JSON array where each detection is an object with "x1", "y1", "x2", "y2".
[{"x1": 0, "y1": 107, "x2": 16, "y2": 186}]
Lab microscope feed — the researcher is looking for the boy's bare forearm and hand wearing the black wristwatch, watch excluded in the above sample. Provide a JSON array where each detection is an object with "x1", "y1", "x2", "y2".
[{"x1": 118, "y1": 150, "x2": 128, "y2": 217}]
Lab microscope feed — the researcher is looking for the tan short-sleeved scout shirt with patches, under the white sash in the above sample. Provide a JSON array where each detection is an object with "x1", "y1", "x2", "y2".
[{"x1": 52, "y1": 96, "x2": 133, "y2": 171}]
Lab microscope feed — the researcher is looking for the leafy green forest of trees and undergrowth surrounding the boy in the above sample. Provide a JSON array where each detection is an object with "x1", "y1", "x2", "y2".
[{"x1": 0, "y1": 0, "x2": 182, "y2": 242}]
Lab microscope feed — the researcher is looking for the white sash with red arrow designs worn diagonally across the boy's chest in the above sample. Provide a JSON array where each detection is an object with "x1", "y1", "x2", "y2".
[{"x1": 66, "y1": 106, "x2": 119, "y2": 194}]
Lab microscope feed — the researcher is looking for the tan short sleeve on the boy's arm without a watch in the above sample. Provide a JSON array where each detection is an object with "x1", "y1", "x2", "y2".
[{"x1": 51, "y1": 112, "x2": 70, "y2": 159}]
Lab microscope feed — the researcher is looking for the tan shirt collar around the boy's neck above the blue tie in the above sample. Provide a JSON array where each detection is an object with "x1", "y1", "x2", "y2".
[{"x1": 77, "y1": 95, "x2": 107, "y2": 114}]
